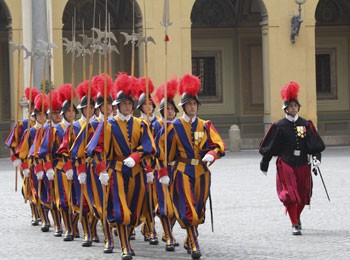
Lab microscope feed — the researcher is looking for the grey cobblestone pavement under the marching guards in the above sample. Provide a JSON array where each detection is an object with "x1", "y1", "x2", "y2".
[{"x1": 0, "y1": 147, "x2": 350, "y2": 260}]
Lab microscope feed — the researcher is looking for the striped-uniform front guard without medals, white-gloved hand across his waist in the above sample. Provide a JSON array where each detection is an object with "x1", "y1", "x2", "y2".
[{"x1": 87, "y1": 73, "x2": 155, "y2": 260}]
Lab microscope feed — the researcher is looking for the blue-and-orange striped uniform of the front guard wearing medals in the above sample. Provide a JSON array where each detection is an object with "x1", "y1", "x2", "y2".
[{"x1": 156, "y1": 117, "x2": 225, "y2": 254}]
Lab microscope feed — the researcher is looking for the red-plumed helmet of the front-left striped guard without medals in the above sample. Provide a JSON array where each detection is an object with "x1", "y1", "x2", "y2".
[{"x1": 112, "y1": 73, "x2": 140, "y2": 105}]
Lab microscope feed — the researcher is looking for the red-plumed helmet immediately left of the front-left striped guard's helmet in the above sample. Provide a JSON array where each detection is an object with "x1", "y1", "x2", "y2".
[{"x1": 91, "y1": 73, "x2": 115, "y2": 108}]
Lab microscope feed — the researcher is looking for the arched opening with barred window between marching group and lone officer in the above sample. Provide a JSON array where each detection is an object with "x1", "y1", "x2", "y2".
[{"x1": 191, "y1": 0, "x2": 268, "y2": 142}]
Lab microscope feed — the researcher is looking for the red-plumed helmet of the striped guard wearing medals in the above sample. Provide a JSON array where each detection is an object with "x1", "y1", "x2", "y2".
[{"x1": 179, "y1": 74, "x2": 201, "y2": 106}]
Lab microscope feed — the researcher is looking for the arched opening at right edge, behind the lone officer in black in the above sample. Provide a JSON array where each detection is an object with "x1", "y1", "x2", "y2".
[{"x1": 315, "y1": 0, "x2": 350, "y2": 140}]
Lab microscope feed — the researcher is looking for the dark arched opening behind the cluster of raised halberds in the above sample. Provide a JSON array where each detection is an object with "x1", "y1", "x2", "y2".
[{"x1": 62, "y1": 0, "x2": 142, "y2": 83}]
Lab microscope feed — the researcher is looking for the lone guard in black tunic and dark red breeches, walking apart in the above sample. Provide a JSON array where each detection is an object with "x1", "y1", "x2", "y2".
[{"x1": 259, "y1": 81, "x2": 325, "y2": 235}]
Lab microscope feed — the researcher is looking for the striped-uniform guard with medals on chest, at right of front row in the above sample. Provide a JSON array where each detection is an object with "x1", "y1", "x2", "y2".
[{"x1": 156, "y1": 74, "x2": 225, "y2": 259}]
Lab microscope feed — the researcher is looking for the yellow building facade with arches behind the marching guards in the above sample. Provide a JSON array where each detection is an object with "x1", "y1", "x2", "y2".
[{"x1": 0, "y1": 0, "x2": 350, "y2": 155}]
